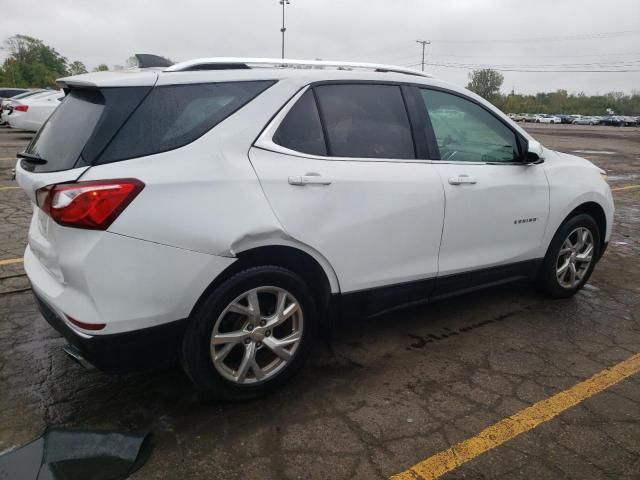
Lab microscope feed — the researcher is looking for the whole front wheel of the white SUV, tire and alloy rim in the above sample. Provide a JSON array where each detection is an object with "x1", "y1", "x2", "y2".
[{"x1": 536, "y1": 213, "x2": 600, "y2": 298}]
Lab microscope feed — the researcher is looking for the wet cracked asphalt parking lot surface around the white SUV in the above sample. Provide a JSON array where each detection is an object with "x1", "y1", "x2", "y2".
[{"x1": 0, "y1": 125, "x2": 640, "y2": 480}]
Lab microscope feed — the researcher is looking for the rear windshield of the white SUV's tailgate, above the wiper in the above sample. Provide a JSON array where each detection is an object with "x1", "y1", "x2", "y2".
[{"x1": 23, "y1": 90, "x2": 104, "y2": 172}]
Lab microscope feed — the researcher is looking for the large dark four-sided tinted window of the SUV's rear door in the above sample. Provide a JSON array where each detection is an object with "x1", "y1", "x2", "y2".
[{"x1": 316, "y1": 84, "x2": 415, "y2": 159}]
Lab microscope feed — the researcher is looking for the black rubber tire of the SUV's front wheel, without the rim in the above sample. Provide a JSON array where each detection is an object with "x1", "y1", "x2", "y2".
[{"x1": 536, "y1": 213, "x2": 601, "y2": 298}]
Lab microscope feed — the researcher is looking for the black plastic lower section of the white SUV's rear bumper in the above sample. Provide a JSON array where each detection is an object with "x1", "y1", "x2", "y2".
[{"x1": 34, "y1": 292, "x2": 187, "y2": 373}]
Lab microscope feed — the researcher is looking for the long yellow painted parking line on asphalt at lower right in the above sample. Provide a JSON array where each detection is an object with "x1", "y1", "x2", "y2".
[{"x1": 391, "y1": 353, "x2": 640, "y2": 480}]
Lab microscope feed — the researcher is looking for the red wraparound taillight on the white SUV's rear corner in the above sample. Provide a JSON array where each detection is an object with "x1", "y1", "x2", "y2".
[{"x1": 36, "y1": 178, "x2": 144, "y2": 230}]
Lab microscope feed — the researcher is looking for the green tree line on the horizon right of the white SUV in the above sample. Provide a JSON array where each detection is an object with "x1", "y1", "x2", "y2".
[{"x1": 467, "y1": 69, "x2": 640, "y2": 115}]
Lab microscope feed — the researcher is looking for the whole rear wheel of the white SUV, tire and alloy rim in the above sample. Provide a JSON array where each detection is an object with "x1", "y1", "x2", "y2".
[{"x1": 182, "y1": 266, "x2": 318, "y2": 401}]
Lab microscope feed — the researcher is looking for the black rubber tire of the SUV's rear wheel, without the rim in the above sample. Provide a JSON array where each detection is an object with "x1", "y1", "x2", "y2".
[{"x1": 181, "y1": 266, "x2": 319, "y2": 401}]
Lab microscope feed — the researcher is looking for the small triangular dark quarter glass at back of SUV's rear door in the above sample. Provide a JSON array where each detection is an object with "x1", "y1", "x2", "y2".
[{"x1": 273, "y1": 90, "x2": 327, "y2": 155}]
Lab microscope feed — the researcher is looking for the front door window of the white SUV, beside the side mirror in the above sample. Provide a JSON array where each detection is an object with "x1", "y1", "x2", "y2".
[{"x1": 420, "y1": 89, "x2": 520, "y2": 162}]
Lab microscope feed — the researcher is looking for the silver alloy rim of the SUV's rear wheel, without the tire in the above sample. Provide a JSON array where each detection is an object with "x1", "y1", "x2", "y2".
[{"x1": 211, "y1": 286, "x2": 304, "y2": 385}]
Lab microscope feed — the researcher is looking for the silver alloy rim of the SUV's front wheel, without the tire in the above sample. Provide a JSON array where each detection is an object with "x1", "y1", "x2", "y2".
[{"x1": 556, "y1": 227, "x2": 594, "y2": 289}]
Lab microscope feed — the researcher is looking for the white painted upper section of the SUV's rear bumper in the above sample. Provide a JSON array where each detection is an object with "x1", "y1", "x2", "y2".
[{"x1": 24, "y1": 229, "x2": 236, "y2": 337}]
